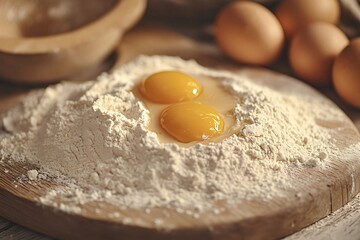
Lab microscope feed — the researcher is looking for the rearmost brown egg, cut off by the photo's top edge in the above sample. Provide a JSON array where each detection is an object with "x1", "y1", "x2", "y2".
[{"x1": 275, "y1": 0, "x2": 340, "y2": 38}]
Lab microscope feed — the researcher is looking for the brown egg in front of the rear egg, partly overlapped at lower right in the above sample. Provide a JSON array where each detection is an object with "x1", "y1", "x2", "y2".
[{"x1": 289, "y1": 22, "x2": 349, "y2": 86}]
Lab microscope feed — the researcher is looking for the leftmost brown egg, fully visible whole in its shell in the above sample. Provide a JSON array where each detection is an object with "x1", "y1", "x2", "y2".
[{"x1": 215, "y1": 1, "x2": 284, "y2": 65}]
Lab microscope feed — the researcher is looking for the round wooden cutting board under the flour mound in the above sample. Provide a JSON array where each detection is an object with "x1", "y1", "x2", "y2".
[{"x1": 0, "y1": 24, "x2": 360, "y2": 240}]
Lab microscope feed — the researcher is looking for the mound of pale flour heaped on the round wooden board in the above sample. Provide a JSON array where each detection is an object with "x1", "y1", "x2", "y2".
[{"x1": 0, "y1": 56, "x2": 339, "y2": 212}]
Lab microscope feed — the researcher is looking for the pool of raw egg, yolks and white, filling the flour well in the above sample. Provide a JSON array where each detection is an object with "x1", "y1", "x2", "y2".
[{"x1": 134, "y1": 71, "x2": 236, "y2": 146}]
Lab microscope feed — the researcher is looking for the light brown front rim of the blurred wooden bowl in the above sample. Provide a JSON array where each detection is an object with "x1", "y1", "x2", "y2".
[{"x1": 0, "y1": 0, "x2": 146, "y2": 55}]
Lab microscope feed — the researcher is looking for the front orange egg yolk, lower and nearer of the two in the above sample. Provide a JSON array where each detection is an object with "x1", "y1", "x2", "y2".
[{"x1": 160, "y1": 101, "x2": 224, "y2": 143}]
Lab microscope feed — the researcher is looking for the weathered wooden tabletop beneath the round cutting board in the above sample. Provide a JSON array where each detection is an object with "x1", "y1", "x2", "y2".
[{"x1": 0, "y1": 22, "x2": 360, "y2": 240}]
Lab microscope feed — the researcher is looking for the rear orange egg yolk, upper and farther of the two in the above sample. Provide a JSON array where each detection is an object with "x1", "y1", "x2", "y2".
[{"x1": 140, "y1": 71, "x2": 201, "y2": 104}]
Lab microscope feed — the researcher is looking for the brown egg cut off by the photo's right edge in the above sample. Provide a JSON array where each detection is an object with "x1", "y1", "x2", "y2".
[{"x1": 333, "y1": 37, "x2": 360, "y2": 109}]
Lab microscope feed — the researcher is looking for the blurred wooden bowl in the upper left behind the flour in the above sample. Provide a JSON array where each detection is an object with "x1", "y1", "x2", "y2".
[{"x1": 0, "y1": 0, "x2": 146, "y2": 84}]
